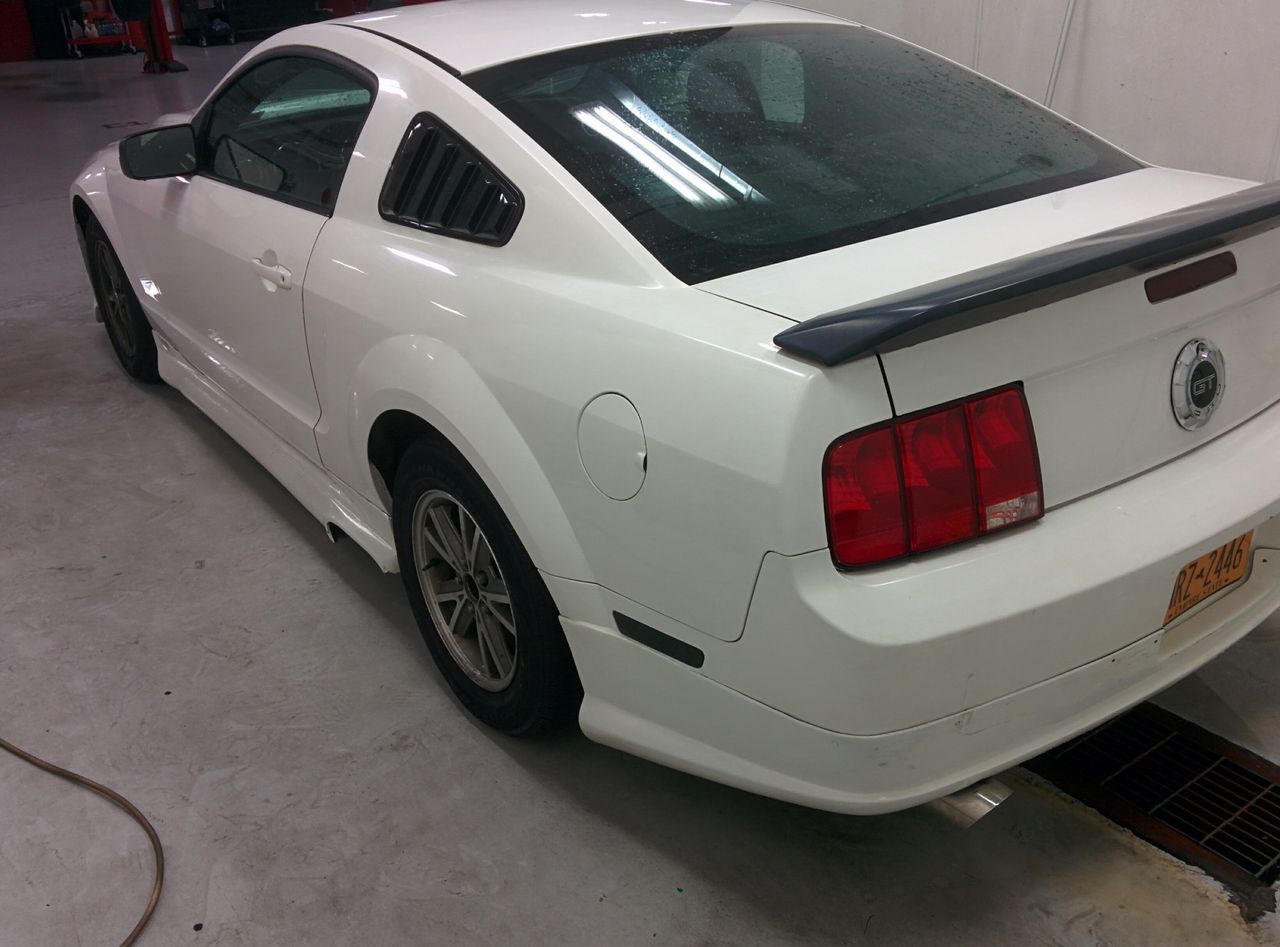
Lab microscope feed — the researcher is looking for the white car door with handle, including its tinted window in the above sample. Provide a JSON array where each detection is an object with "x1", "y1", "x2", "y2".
[{"x1": 120, "y1": 47, "x2": 374, "y2": 462}]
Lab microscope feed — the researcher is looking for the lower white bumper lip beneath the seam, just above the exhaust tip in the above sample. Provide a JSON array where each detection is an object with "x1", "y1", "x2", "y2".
[{"x1": 563, "y1": 550, "x2": 1280, "y2": 814}]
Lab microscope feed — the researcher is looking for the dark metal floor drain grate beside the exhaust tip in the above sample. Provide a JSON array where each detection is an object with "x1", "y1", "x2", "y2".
[{"x1": 1025, "y1": 704, "x2": 1280, "y2": 900}]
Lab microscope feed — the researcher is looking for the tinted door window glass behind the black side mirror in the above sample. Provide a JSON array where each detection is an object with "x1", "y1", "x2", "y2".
[{"x1": 200, "y1": 56, "x2": 374, "y2": 214}]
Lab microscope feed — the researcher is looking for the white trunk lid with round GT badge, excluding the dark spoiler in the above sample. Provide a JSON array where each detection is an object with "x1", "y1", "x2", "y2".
[{"x1": 699, "y1": 168, "x2": 1280, "y2": 507}]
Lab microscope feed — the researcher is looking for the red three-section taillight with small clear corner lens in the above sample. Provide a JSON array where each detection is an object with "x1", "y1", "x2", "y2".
[{"x1": 822, "y1": 385, "x2": 1044, "y2": 568}]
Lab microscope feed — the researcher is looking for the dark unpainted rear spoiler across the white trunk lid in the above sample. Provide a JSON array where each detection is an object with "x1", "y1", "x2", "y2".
[{"x1": 773, "y1": 182, "x2": 1280, "y2": 365}]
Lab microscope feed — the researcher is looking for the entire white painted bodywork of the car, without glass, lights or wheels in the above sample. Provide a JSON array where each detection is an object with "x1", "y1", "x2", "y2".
[{"x1": 73, "y1": 0, "x2": 1280, "y2": 813}]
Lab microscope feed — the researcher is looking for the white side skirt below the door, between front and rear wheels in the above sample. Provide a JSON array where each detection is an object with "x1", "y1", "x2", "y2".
[{"x1": 154, "y1": 333, "x2": 399, "y2": 572}]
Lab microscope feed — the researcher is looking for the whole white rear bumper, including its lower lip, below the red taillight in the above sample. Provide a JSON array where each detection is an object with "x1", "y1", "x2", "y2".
[{"x1": 548, "y1": 399, "x2": 1280, "y2": 813}]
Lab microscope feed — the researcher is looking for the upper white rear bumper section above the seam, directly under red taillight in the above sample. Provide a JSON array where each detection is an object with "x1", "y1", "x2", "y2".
[{"x1": 707, "y1": 396, "x2": 1280, "y2": 735}]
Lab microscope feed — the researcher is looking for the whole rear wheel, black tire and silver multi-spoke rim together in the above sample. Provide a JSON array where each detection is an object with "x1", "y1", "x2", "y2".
[{"x1": 393, "y1": 440, "x2": 581, "y2": 735}]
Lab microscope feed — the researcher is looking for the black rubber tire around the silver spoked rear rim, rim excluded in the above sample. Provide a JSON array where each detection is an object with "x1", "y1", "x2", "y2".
[{"x1": 392, "y1": 439, "x2": 582, "y2": 736}]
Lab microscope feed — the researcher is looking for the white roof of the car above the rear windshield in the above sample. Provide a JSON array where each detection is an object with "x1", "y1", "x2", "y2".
[{"x1": 329, "y1": 0, "x2": 842, "y2": 74}]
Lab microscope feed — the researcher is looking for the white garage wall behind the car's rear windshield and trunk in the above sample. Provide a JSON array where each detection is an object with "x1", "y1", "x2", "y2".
[{"x1": 797, "y1": 0, "x2": 1280, "y2": 180}]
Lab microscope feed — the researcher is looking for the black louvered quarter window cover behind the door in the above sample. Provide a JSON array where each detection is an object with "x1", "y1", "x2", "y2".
[{"x1": 379, "y1": 113, "x2": 524, "y2": 244}]
